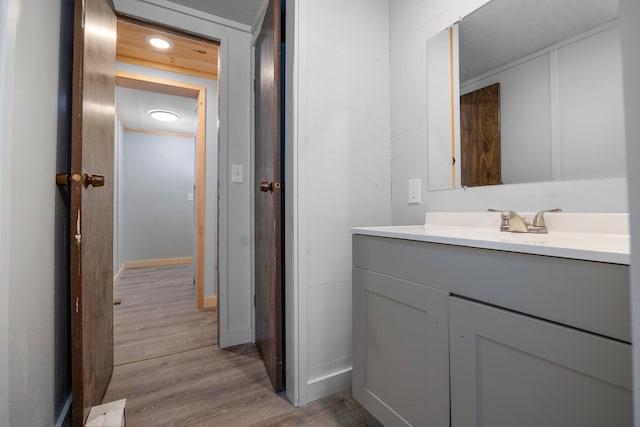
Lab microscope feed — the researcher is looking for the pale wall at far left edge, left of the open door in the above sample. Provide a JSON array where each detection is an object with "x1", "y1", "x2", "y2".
[{"x1": 0, "y1": 0, "x2": 60, "y2": 427}]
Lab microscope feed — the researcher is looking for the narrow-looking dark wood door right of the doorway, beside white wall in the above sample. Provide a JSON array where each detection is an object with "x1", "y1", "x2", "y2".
[{"x1": 255, "y1": 0, "x2": 283, "y2": 391}]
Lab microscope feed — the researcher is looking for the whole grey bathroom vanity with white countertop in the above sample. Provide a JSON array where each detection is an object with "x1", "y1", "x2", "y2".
[{"x1": 352, "y1": 213, "x2": 633, "y2": 427}]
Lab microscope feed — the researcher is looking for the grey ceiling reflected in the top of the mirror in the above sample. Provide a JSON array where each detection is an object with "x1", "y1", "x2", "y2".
[{"x1": 460, "y1": 0, "x2": 618, "y2": 81}]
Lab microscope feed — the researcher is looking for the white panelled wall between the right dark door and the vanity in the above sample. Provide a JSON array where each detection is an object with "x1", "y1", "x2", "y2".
[{"x1": 285, "y1": 0, "x2": 391, "y2": 404}]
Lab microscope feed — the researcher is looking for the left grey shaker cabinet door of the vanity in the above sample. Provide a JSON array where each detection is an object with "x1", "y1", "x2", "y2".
[{"x1": 353, "y1": 268, "x2": 449, "y2": 427}]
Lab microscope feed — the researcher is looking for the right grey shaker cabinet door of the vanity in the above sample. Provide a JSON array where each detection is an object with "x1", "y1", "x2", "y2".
[{"x1": 449, "y1": 297, "x2": 633, "y2": 427}]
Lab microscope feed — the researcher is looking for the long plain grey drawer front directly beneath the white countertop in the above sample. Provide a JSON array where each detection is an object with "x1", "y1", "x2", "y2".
[{"x1": 353, "y1": 235, "x2": 631, "y2": 342}]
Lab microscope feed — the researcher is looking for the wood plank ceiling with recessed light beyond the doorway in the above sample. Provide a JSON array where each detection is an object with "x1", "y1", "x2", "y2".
[{"x1": 116, "y1": 19, "x2": 218, "y2": 80}]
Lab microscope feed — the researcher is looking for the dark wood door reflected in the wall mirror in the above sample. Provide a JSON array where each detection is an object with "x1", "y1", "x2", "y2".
[{"x1": 460, "y1": 83, "x2": 502, "y2": 187}]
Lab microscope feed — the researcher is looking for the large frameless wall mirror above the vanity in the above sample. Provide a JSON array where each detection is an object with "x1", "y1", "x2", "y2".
[{"x1": 427, "y1": 0, "x2": 626, "y2": 190}]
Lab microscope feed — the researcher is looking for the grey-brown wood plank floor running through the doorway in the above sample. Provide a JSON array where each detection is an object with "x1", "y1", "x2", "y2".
[{"x1": 104, "y1": 265, "x2": 365, "y2": 427}]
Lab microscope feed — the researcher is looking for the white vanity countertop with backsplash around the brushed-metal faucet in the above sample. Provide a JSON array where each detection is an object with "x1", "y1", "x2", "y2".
[{"x1": 351, "y1": 212, "x2": 630, "y2": 265}]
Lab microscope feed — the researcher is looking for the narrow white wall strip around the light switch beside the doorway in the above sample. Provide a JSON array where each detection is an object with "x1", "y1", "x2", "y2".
[{"x1": 218, "y1": 29, "x2": 254, "y2": 347}]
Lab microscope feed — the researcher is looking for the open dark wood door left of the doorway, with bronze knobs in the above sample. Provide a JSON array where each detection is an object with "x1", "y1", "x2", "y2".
[{"x1": 69, "y1": 0, "x2": 116, "y2": 426}]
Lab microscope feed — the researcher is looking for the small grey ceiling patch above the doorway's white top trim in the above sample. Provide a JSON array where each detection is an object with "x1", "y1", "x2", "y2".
[{"x1": 164, "y1": 0, "x2": 268, "y2": 27}]
